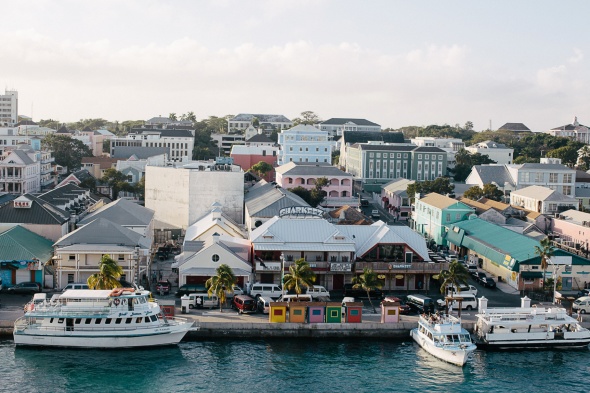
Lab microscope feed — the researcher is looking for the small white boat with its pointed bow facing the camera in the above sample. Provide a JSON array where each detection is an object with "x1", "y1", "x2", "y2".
[{"x1": 410, "y1": 314, "x2": 477, "y2": 366}]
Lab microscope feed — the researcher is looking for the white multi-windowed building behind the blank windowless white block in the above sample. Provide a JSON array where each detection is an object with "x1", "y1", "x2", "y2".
[{"x1": 110, "y1": 128, "x2": 195, "y2": 162}]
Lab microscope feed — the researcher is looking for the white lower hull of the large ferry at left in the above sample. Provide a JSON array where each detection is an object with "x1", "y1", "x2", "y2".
[{"x1": 14, "y1": 324, "x2": 190, "y2": 349}]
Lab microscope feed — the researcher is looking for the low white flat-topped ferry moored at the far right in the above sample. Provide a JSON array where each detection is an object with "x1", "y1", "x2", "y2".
[{"x1": 474, "y1": 296, "x2": 590, "y2": 349}]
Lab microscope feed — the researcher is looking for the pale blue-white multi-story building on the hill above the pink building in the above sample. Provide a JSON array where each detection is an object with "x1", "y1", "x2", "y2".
[{"x1": 278, "y1": 124, "x2": 332, "y2": 165}]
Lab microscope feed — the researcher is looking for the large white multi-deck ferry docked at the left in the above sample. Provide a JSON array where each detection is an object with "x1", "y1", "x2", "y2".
[{"x1": 14, "y1": 288, "x2": 192, "y2": 348}]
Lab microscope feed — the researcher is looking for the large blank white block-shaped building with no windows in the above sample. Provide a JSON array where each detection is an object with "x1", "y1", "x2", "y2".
[{"x1": 145, "y1": 161, "x2": 244, "y2": 229}]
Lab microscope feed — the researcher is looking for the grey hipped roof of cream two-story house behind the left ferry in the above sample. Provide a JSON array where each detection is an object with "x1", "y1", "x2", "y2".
[{"x1": 55, "y1": 218, "x2": 151, "y2": 248}]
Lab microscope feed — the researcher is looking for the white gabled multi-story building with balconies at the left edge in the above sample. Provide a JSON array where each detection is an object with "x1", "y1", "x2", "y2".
[{"x1": 0, "y1": 145, "x2": 41, "y2": 194}]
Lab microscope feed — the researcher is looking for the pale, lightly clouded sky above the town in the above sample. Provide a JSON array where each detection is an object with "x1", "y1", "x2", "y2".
[{"x1": 0, "y1": 0, "x2": 590, "y2": 131}]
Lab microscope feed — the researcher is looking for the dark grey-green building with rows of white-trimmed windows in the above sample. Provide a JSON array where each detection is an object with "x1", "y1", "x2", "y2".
[{"x1": 346, "y1": 142, "x2": 447, "y2": 193}]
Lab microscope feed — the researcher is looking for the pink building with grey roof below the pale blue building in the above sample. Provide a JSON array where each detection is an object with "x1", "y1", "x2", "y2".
[{"x1": 276, "y1": 162, "x2": 356, "y2": 206}]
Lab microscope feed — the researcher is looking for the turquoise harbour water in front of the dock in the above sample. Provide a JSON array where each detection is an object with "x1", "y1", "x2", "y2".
[{"x1": 0, "y1": 339, "x2": 590, "y2": 393}]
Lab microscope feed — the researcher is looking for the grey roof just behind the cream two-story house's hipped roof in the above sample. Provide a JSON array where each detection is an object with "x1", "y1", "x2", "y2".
[{"x1": 80, "y1": 198, "x2": 154, "y2": 226}]
